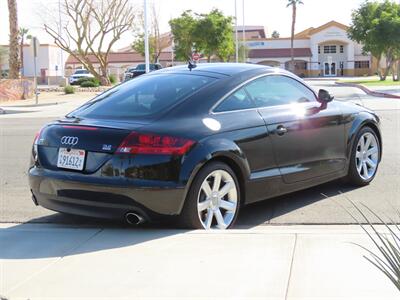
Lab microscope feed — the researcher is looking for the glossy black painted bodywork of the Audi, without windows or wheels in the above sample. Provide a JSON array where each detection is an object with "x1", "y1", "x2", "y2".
[{"x1": 29, "y1": 64, "x2": 382, "y2": 223}]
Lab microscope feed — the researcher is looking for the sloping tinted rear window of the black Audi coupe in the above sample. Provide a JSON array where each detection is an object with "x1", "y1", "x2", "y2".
[{"x1": 70, "y1": 74, "x2": 216, "y2": 119}]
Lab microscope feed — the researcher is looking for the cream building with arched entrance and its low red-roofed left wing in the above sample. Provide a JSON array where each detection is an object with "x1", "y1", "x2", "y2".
[{"x1": 246, "y1": 21, "x2": 376, "y2": 76}]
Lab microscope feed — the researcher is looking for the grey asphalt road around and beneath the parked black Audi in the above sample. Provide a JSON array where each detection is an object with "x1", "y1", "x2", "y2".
[{"x1": 0, "y1": 82, "x2": 400, "y2": 228}]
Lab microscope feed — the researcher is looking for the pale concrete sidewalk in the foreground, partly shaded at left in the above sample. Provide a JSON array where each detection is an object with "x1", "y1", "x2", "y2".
[{"x1": 0, "y1": 224, "x2": 400, "y2": 300}]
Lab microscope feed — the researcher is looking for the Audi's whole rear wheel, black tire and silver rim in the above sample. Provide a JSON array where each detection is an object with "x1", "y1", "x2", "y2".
[{"x1": 181, "y1": 162, "x2": 240, "y2": 229}]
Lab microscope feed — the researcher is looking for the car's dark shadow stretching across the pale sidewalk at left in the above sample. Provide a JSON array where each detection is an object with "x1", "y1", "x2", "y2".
[{"x1": 0, "y1": 217, "x2": 189, "y2": 262}]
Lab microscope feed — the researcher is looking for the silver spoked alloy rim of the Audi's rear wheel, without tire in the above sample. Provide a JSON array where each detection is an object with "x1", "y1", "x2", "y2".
[{"x1": 197, "y1": 170, "x2": 238, "y2": 229}]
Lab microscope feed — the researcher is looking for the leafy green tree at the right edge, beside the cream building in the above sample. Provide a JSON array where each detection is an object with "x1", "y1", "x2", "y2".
[{"x1": 348, "y1": 0, "x2": 400, "y2": 80}]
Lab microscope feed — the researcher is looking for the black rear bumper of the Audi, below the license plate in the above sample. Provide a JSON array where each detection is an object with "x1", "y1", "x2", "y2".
[{"x1": 29, "y1": 167, "x2": 185, "y2": 220}]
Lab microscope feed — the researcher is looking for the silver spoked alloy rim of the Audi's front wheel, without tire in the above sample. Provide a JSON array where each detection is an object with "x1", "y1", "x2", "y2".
[{"x1": 355, "y1": 132, "x2": 379, "y2": 180}]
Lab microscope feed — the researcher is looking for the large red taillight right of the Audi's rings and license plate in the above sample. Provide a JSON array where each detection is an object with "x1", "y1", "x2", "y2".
[{"x1": 116, "y1": 132, "x2": 194, "y2": 155}]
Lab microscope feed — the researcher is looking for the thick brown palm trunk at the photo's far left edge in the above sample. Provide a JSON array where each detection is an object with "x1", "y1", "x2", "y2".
[{"x1": 7, "y1": 0, "x2": 19, "y2": 79}]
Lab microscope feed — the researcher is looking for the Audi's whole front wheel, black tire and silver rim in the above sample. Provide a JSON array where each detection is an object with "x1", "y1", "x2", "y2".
[{"x1": 347, "y1": 127, "x2": 380, "y2": 186}]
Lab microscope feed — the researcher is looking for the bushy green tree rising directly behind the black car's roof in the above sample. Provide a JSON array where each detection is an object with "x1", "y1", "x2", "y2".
[{"x1": 169, "y1": 9, "x2": 235, "y2": 62}]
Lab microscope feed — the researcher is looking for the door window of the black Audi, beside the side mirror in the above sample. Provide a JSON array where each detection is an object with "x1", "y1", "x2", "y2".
[{"x1": 246, "y1": 75, "x2": 317, "y2": 107}]
